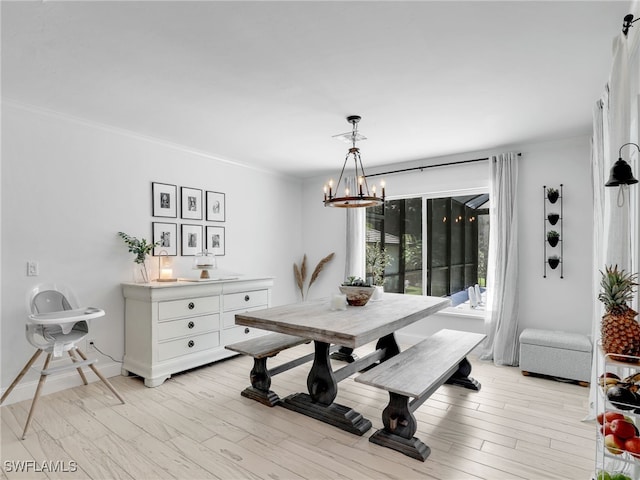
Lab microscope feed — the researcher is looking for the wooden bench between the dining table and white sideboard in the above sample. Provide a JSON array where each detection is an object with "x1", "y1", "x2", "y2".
[{"x1": 225, "y1": 333, "x2": 339, "y2": 407}]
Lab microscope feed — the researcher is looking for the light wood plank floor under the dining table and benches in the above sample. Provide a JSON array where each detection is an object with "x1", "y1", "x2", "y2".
[{"x1": 0, "y1": 345, "x2": 595, "y2": 480}]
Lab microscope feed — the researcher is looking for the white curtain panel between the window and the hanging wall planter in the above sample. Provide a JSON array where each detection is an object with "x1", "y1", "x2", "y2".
[{"x1": 480, "y1": 153, "x2": 518, "y2": 365}]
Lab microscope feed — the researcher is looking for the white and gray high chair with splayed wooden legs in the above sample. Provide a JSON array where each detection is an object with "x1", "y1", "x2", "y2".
[{"x1": 0, "y1": 284, "x2": 124, "y2": 440}]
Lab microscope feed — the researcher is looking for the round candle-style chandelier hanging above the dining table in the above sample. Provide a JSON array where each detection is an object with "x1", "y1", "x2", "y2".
[{"x1": 324, "y1": 115, "x2": 385, "y2": 208}]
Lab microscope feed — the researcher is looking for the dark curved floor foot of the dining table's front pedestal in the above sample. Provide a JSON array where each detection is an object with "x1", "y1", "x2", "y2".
[{"x1": 279, "y1": 393, "x2": 371, "y2": 435}]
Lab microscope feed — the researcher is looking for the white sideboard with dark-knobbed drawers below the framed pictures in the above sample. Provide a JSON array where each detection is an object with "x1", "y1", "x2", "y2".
[{"x1": 122, "y1": 277, "x2": 273, "y2": 387}]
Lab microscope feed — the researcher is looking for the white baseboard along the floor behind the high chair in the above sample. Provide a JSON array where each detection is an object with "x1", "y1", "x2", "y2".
[{"x1": 2, "y1": 362, "x2": 122, "y2": 406}]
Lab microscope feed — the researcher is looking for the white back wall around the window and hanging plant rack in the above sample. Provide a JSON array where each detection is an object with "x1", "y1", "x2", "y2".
[{"x1": 302, "y1": 137, "x2": 593, "y2": 342}]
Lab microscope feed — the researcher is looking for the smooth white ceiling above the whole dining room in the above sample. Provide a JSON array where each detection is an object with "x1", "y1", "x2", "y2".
[{"x1": 1, "y1": 0, "x2": 631, "y2": 177}]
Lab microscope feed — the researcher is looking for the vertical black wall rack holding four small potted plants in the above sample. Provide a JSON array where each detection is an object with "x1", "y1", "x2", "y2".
[{"x1": 542, "y1": 184, "x2": 564, "y2": 278}]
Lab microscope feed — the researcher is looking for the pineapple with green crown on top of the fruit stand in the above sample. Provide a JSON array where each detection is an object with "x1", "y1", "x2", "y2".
[{"x1": 598, "y1": 265, "x2": 640, "y2": 361}]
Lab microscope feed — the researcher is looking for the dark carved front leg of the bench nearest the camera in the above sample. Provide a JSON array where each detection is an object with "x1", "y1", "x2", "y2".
[{"x1": 369, "y1": 392, "x2": 431, "y2": 462}]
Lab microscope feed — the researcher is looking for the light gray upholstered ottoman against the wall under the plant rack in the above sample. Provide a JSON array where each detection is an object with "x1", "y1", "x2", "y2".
[{"x1": 520, "y1": 328, "x2": 592, "y2": 386}]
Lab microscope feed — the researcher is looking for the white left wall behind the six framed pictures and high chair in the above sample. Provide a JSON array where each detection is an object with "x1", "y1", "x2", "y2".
[{"x1": 1, "y1": 102, "x2": 302, "y2": 401}]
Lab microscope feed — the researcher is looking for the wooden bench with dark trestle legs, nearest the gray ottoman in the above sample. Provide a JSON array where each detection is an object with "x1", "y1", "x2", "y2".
[{"x1": 355, "y1": 329, "x2": 485, "y2": 462}]
